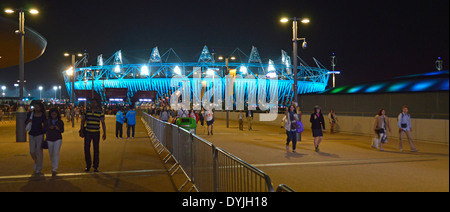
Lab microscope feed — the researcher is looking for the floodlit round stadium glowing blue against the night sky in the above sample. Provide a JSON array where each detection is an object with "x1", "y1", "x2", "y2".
[{"x1": 63, "y1": 46, "x2": 329, "y2": 106}]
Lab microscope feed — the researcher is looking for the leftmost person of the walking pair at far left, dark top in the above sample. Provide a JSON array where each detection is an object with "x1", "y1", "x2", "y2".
[{"x1": 25, "y1": 102, "x2": 48, "y2": 175}]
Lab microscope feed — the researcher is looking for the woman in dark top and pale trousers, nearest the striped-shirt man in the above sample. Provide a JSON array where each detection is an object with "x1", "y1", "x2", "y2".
[{"x1": 46, "y1": 108, "x2": 64, "y2": 176}]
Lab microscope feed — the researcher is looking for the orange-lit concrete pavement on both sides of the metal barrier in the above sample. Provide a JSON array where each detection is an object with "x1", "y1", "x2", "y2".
[{"x1": 0, "y1": 117, "x2": 449, "y2": 192}]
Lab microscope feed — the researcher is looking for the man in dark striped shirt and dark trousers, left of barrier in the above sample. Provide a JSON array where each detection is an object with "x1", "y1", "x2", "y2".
[{"x1": 79, "y1": 98, "x2": 106, "y2": 172}]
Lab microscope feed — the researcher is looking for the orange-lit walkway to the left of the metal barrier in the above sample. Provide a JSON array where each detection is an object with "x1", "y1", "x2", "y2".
[{"x1": 0, "y1": 116, "x2": 176, "y2": 192}]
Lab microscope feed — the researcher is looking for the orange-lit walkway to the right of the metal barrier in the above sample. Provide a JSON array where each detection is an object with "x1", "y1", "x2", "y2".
[{"x1": 197, "y1": 119, "x2": 449, "y2": 192}]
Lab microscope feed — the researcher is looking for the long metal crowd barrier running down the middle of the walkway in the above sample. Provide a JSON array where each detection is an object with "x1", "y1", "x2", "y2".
[{"x1": 142, "y1": 113, "x2": 293, "y2": 192}]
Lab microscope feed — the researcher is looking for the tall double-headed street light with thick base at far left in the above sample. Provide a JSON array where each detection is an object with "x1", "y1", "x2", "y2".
[{"x1": 5, "y1": 8, "x2": 39, "y2": 142}]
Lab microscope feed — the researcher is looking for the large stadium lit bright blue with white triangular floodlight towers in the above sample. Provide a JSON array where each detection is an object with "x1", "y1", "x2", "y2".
[{"x1": 63, "y1": 46, "x2": 329, "y2": 105}]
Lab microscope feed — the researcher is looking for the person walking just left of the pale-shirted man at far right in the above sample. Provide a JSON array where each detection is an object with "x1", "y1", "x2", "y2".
[{"x1": 372, "y1": 109, "x2": 391, "y2": 151}]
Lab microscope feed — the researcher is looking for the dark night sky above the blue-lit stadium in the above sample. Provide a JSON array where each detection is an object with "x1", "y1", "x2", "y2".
[{"x1": 0, "y1": 0, "x2": 449, "y2": 97}]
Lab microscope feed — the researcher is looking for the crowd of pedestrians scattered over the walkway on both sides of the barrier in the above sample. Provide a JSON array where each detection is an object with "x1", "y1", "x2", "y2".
[{"x1": 17, "y1": 98, "x2": 417, "y2": 176}]
